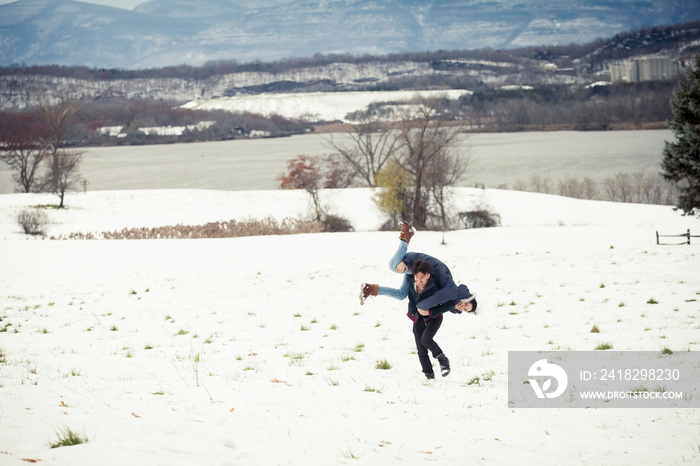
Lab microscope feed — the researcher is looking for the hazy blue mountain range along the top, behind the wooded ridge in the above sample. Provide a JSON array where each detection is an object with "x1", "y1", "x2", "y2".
[{"x1": 0, "y1": 0, "x2": 700, "y2": 69}]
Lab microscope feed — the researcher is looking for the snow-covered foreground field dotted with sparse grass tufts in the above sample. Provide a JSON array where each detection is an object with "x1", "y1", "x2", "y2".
[{"x1": 0, "y1": 188, "x2": 700, "y2": 466}]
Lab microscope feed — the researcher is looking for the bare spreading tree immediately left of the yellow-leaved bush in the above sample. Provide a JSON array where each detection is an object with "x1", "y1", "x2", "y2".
[{"x1": 326, "y1": 112, "x2": 397, "y2": 187}]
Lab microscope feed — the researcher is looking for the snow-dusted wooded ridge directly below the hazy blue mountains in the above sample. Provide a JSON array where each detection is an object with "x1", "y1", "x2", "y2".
[{"x1": 0, "y1": 22, "x2": 700, "y2": 109}]
